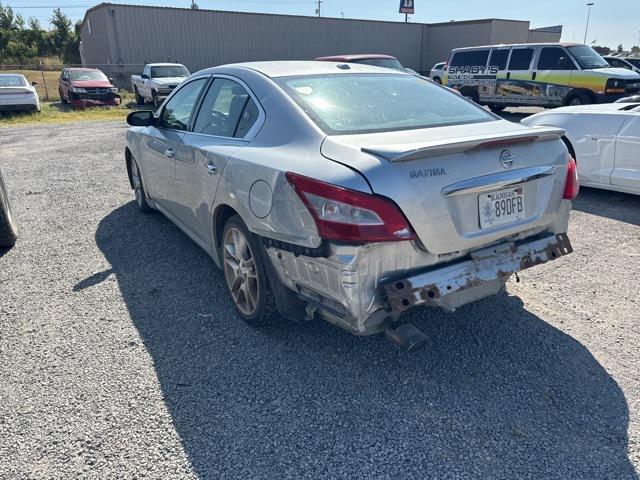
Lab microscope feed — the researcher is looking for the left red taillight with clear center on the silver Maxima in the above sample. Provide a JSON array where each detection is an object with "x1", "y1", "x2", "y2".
[{"x1": 287, "y1": 172, "x2": 416, "y2": 242}]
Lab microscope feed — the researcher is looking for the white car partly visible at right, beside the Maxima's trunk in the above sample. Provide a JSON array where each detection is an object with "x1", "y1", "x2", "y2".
[{"x1": 522, "y1": 103, "x2": 640, "y2": 195}]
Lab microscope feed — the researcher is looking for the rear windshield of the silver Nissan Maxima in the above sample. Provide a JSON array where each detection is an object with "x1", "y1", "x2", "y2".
[{"x1": 277, "y1": 73, "x2": 496, "y2": 134}]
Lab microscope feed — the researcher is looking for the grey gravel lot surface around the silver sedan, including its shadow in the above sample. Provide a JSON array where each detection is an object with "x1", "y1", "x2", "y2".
[{"x1": 0, "y1": 123, "x2": 640, "y2": 480}]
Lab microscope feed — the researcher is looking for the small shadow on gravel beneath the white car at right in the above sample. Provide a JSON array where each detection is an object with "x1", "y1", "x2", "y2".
[{"x1": 573, "y1": 187, "x2": 640, "y2": 225}]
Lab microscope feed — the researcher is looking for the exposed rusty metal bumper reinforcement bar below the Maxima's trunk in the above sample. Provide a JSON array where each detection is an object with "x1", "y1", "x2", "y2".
[{"x1": 380, "y1": 233, "x2": 573, "y2": 314}]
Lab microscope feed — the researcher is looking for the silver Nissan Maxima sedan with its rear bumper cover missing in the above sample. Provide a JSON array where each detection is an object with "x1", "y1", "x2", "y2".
[{"x1": 125, "y1": 62, "x2": 578, "y2": 349}]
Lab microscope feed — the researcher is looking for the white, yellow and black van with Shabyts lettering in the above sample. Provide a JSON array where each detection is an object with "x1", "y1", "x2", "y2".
[{"x1": 444, "y1": 43, "x2": 640, "y2": 110}]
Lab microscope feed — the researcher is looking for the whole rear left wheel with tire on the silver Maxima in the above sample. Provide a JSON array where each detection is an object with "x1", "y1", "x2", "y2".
[{"x1": 222, "y1": 215, "x2": 278, "y2": 327}]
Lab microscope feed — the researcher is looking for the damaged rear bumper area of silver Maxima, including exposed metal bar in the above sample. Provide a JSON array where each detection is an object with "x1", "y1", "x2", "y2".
[{"x1": 265, "y1": 230, "x2": 573, "y2": 335}]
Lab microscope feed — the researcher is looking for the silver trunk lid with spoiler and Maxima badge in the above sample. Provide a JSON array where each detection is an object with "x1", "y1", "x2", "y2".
[{"x1": 321, "y1": 120, "x2": 567, "y2": 254}]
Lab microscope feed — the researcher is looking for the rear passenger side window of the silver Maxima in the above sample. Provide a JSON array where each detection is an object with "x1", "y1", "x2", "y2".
[{"x1": 193, "y1": 78, "x2": 258, "y2": 138}]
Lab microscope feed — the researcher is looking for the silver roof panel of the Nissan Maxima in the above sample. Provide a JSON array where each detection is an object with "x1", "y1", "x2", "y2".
[{"x1": 199, "y1": 60, "x2": 408, "y2": 78}]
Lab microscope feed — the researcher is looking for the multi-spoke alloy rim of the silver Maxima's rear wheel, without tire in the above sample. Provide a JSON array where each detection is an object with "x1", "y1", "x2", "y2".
[{"x1": 223, "y1": 227, "x2": 260, "y2": 316}]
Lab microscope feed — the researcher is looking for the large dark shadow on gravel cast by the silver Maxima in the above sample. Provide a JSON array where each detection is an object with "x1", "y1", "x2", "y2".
[{"x1": 92, "y1": 202, "x2": 638, "y2": 479}]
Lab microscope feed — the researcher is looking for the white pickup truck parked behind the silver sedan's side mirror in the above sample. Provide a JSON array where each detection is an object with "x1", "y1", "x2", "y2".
[{"x1": 131, "y1": 63, "x2": 190, "y2": 108}]
